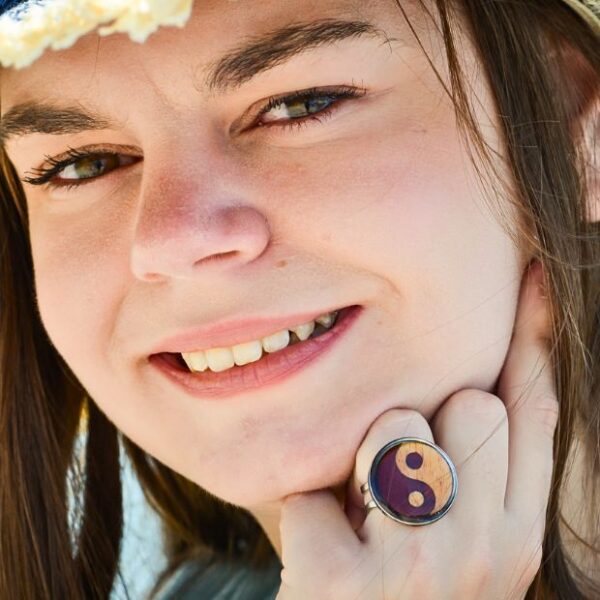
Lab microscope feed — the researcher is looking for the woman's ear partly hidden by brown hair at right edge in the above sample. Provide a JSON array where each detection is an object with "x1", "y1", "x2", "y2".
[{"x1": 556, "y1": 39, "x2": 600, "y2": 222}]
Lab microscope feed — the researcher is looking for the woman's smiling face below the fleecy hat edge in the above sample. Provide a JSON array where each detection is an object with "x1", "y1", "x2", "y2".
[{"x1": 1, "y1": 0, "x2": 525, "y2": 507}]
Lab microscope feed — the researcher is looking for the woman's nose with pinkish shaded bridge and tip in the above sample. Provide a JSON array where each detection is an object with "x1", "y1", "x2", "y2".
[{"x1": 131, "y1": 176, "x2": 270, "y2": 282}]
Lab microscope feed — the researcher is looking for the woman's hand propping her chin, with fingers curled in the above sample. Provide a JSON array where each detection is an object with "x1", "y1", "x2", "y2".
[{"x1": 277, "y1": 261, "x2": 558, "y2": 600}]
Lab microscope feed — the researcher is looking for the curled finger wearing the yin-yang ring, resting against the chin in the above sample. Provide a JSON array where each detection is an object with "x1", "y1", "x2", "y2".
[{"x1": 349, "y1": 409, "x2": 434, "y2": 543}]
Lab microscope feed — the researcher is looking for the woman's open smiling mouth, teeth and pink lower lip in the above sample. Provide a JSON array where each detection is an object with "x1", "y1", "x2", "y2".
[{"x1": 149, "y1": 305, "x2": 362, "y2": 399}]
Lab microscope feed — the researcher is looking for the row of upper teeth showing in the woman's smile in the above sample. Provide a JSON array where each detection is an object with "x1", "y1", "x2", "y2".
[{"x1": 181, "y1": 311, "x2": 339, "y2": 372}]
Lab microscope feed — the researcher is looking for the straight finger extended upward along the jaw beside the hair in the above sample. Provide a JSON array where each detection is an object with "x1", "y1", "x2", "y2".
[{"x1": 497, "y1": 261, "x2": 558, "y2": 527}]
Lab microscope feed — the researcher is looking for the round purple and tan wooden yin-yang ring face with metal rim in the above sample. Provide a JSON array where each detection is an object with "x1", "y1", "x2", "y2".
[{"x1": 369, "y1": 438, "x2": 458, "y2": 525}]
